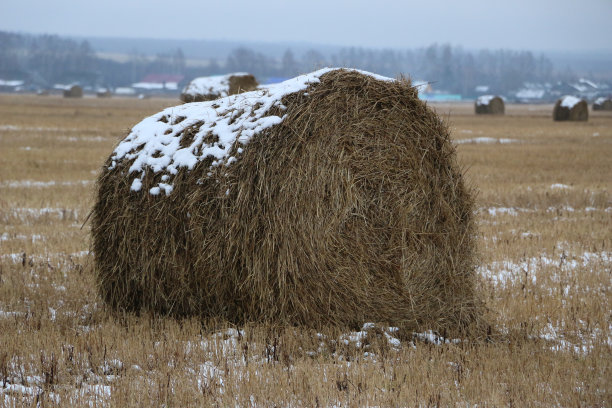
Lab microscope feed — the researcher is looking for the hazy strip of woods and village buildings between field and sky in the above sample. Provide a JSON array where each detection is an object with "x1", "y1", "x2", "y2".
[{"x1": 0, "y1": 31, "x2": 612, "y2": 104}]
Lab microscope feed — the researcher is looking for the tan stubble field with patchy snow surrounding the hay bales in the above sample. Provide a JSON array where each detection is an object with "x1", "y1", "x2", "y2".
[{"x1": 0, "y1": 95, "x2": 612, "y2": 407}]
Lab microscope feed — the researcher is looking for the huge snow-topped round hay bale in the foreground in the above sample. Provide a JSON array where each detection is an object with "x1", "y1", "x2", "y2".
[{"x1": 92, "y1": 68, "x2": 481, "y2": 332}]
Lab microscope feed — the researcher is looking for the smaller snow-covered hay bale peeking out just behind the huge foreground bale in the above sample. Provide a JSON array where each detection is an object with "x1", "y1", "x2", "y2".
[{"x1": 181, "y1": 72, "x2": 259, "y2": 102}]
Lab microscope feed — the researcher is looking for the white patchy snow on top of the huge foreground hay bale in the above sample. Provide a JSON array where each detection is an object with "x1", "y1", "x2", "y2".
[{"x1": 109, "y1": 68, "x2": 393, "y2": 195}]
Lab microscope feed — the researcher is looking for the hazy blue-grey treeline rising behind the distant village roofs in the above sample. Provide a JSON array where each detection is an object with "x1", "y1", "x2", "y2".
[{"x1": 0, "y1": 31, "x2": 571, "y2": 95}]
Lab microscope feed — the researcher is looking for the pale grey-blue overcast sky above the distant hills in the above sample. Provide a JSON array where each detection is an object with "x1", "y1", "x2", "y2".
[{"x1": 0, "y1": 0, "x2": 612, "y2": 52}]
